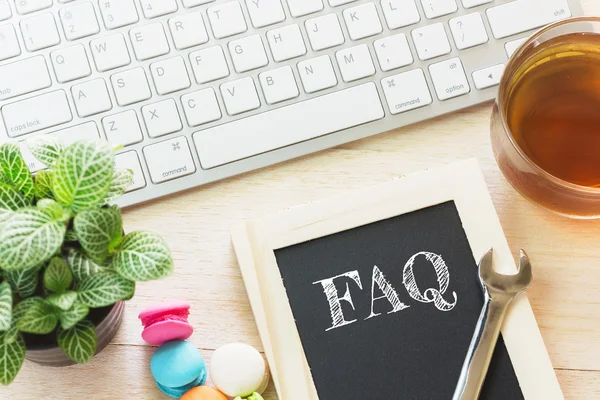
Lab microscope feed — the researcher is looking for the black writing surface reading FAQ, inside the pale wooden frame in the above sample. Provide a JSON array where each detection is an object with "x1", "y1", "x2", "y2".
[{"x1": 275, "y1": 202, "x2": 523, "y2": 400}]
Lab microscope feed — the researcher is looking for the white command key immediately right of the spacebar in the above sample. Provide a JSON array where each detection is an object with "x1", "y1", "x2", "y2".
[{"x1": 381, "y1": 69, "x2": 433, "y2": 114}]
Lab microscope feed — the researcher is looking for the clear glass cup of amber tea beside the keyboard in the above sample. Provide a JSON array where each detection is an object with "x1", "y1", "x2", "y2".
[{"x1": 491, "y1": 17, "x2": 600, "y2": 219}]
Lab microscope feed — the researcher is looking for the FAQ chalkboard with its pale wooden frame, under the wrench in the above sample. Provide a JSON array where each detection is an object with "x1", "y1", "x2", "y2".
[{"x1": 232, "y1": 160, "x2": 564, "y2": 400}]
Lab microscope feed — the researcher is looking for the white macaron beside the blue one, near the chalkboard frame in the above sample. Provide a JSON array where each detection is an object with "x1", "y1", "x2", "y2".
[{"x1": 210, "y1": 343, "x2": 269, "y2": 398}]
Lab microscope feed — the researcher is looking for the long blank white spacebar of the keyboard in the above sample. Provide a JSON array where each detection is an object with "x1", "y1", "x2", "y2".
[{"x1": 194, "y1": 82, "x2": 384, "y2": 169}]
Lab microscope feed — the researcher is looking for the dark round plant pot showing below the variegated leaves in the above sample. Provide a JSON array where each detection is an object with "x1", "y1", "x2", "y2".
[{"x1": 23, "y1": 301, "x2": 125, "y2": 367}]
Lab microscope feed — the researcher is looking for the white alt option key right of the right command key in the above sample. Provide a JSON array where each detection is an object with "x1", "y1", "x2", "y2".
[{"x1": 429, "y1": 57, "x2": 471, "y2": 101}]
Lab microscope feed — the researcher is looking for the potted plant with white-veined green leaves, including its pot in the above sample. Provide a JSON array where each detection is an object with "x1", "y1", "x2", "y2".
[{"x1": 0, "y1": 135, "x2": 173, "y2": 385}]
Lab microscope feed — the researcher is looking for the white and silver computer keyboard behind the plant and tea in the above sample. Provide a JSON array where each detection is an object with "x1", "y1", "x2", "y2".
[{"x1": 0, "y1": 0, "x2": 581, "y2": 206}]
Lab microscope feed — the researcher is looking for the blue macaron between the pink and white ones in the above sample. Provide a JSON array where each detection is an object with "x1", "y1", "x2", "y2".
[{"x1": 150, "y1": 340, "x2": 206, "y2": 399}]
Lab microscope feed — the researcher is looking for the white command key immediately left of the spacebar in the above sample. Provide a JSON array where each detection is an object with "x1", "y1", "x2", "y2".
[{"x1": 144, "y1": 136, "x2": 196, "y2": 183}]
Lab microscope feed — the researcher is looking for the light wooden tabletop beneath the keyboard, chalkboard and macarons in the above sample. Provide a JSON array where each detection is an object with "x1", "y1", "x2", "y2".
[{"x1": 0, "y1": 0, "x2": 600, "y2": 400}]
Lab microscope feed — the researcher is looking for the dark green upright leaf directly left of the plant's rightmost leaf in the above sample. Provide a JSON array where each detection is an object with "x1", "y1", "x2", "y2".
[{"x1": 73, "y1": 207, "x2": 123, "y2": 263}]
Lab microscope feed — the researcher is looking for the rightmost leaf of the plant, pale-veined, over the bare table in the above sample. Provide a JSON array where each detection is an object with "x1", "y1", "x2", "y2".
[{"x1": 112, "y1": 232, "x2": 173, "y2": 281}]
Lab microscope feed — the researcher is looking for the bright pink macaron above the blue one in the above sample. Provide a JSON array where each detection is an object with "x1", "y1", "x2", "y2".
[{"x1": 138, "y1": 301, "x2": 194, "y2": 346}]
